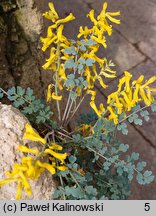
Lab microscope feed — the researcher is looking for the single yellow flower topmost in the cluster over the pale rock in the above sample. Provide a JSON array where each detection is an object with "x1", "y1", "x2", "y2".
[{"x1": 23, "y1": 123, "x2": 46, "y2": 144}]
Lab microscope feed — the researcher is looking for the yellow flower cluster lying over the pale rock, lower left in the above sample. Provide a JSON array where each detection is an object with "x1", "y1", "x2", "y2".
[{"x1": 0, "y1": 124, "x2": 67, "y2": 200}]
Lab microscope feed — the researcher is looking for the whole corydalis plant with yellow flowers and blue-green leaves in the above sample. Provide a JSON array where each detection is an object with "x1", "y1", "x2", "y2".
[{"x1": 0, "y1": 3, "x2": 156, "y2": 199}]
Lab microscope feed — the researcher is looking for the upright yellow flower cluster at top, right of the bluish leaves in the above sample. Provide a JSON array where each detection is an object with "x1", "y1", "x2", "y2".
[{"x1": 78, "y1": 2, "x2": 120, "y2": 95}]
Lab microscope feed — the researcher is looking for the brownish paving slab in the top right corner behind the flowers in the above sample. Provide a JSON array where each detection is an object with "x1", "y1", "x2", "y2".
[{"x1": 92, "y1": 0, "x2": 156, "y2": 43}]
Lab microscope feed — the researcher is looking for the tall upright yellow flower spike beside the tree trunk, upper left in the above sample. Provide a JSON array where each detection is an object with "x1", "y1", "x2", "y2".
[{"x1": 41, "y1": 3, "x2": 75, "y2": 98}]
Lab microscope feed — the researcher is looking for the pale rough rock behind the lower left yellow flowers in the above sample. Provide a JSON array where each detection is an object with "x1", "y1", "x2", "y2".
[{"x1": 0, "y1": 103, "x2": 55, "y2": 200}]
